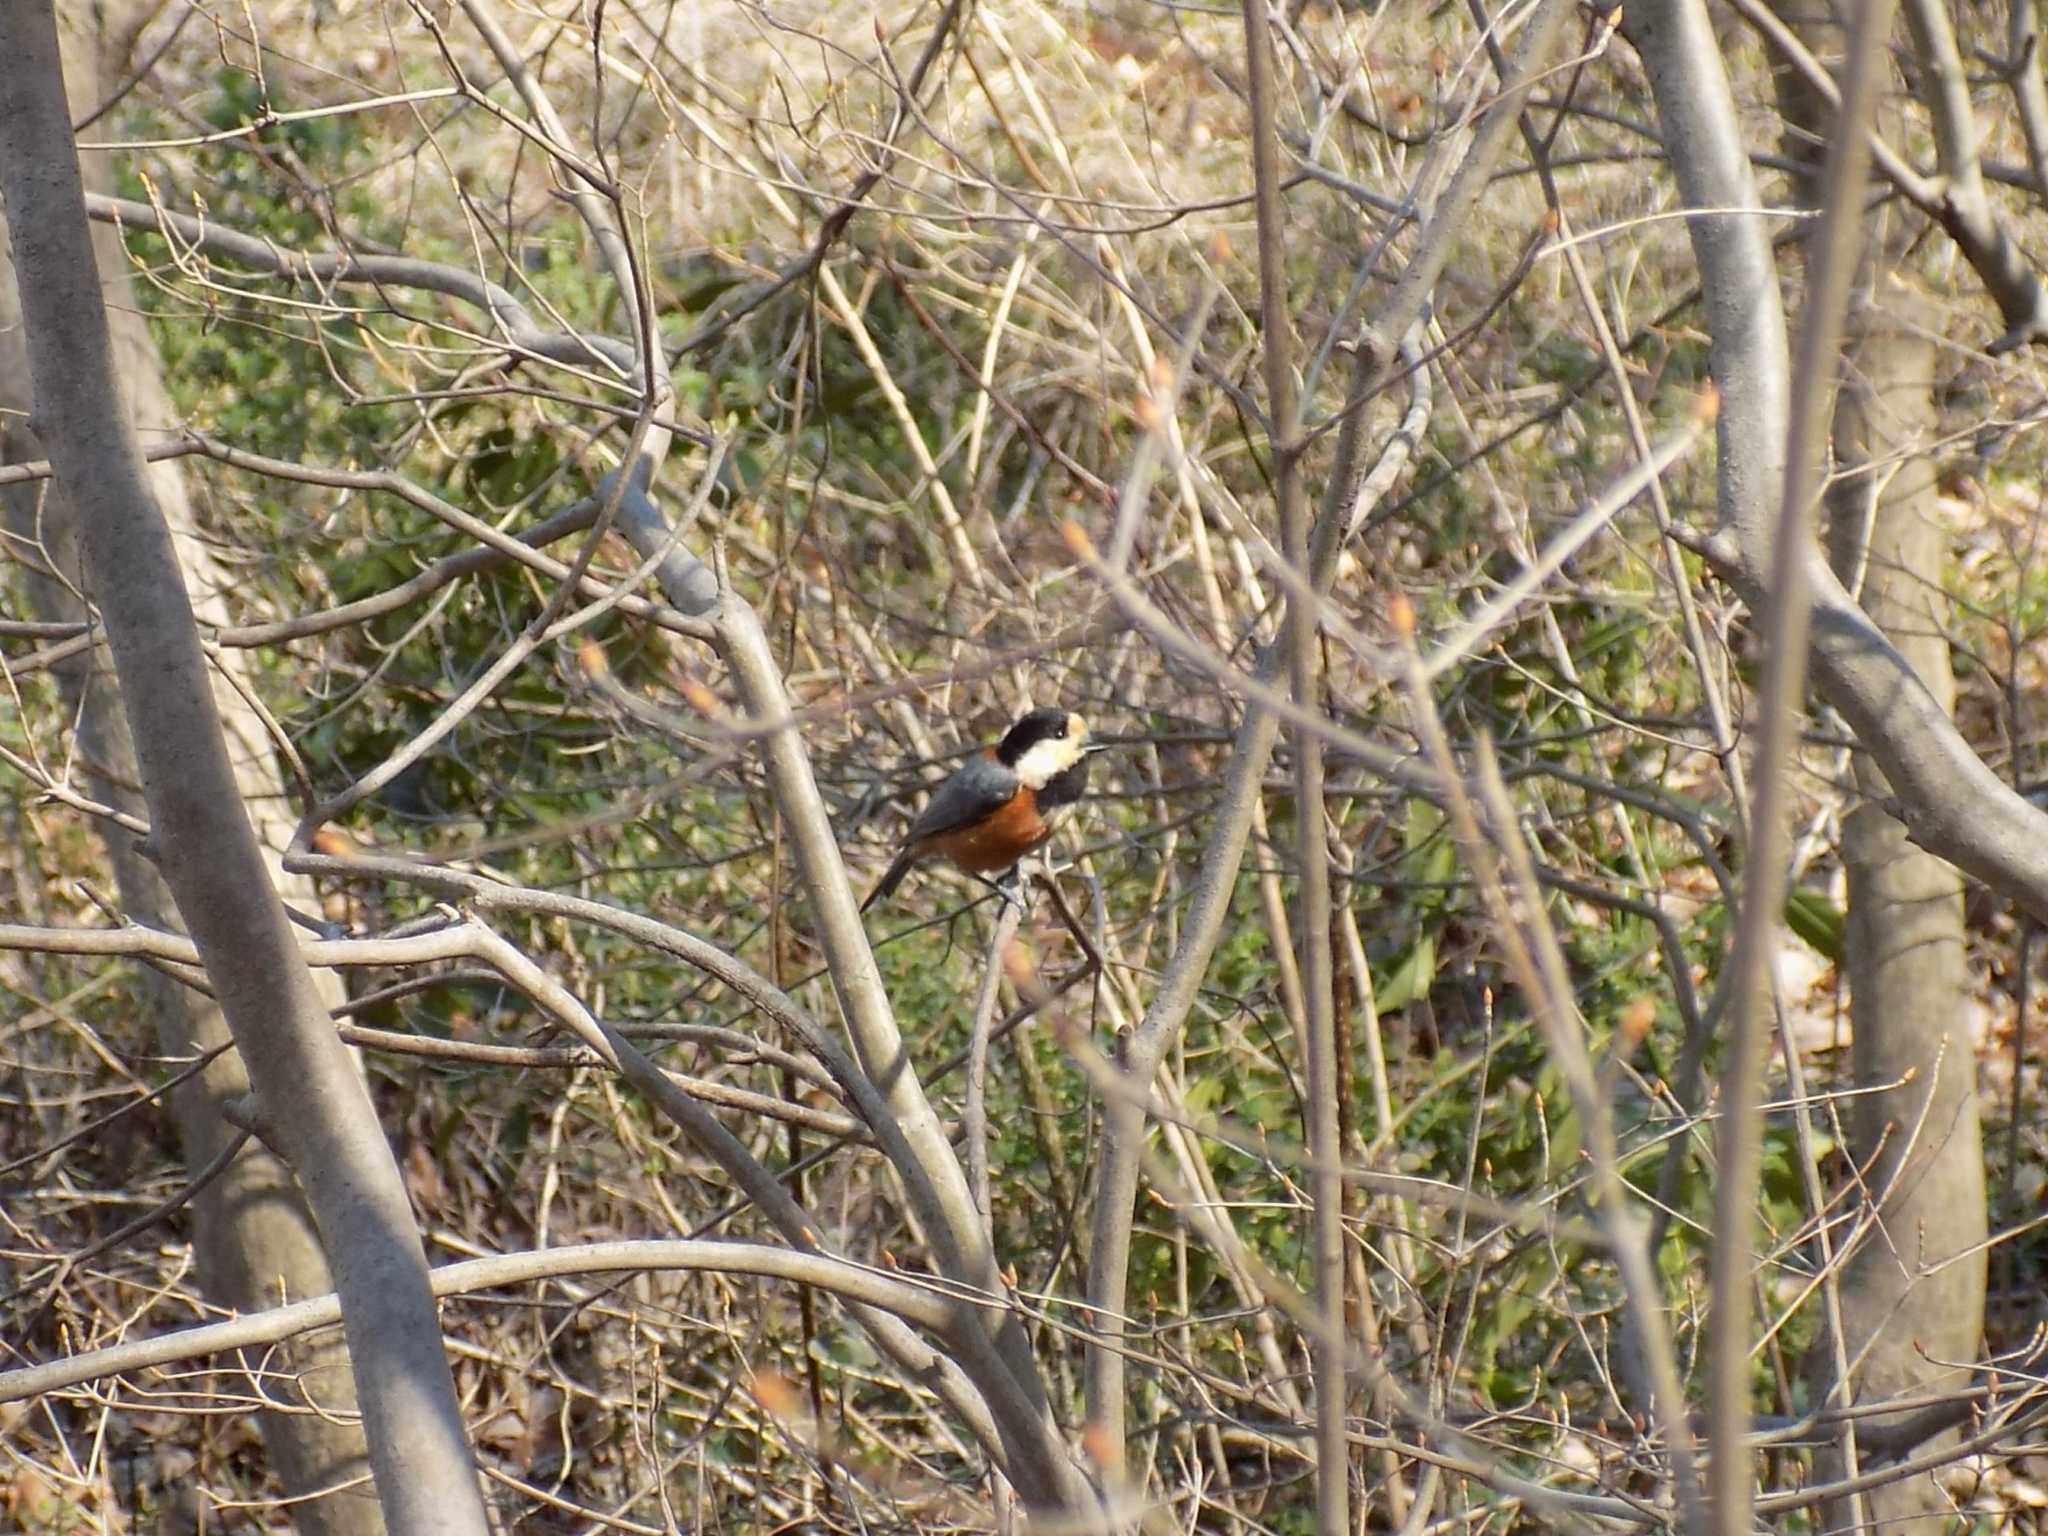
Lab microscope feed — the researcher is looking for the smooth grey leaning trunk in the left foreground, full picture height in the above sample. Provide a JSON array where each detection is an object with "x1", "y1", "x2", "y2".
[{"x1": 0, "y1": 0, "x2": 485, "y2": 1536}]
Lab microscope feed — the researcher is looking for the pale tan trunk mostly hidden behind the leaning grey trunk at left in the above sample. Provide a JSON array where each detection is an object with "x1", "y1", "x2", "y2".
[{"x1": 0, "y1": 6, "x2": 383, "y2": 1536}]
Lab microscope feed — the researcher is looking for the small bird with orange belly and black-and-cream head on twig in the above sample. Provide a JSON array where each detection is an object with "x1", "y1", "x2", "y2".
[{"x1": 860, "y1": 709, "x2": 1092, "y2": 911}]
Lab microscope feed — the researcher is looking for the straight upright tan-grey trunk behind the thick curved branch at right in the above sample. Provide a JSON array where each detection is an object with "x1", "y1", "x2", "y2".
[{"x1": 1780, "y1": 6, "x2": 1989, "y2": 1536}]
